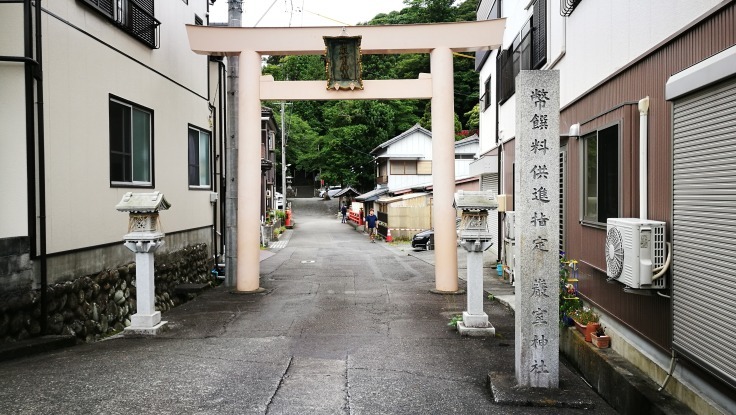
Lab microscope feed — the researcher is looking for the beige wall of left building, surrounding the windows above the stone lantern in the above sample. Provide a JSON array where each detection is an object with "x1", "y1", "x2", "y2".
[{"x1": 43, "y1": 1, "x2": 216, "y2": 253}]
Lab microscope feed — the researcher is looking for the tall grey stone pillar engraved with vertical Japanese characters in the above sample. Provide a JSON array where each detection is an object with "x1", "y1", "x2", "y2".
[{"x1": 515, "y1": 70, "x2": 560, "y2": 388}]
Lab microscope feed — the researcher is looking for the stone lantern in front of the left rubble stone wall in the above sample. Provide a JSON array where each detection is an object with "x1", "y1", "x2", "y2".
[{"x1": 115, "y1": 192, "x2": 171, "y2": 335}]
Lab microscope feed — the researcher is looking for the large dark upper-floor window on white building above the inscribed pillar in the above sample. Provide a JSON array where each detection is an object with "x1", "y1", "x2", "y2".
[{"x1": 496, "y1": 0, "x2": 547, "y2": 104}]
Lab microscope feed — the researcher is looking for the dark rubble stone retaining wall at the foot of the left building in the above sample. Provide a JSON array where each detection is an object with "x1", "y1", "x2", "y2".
[{"x1": 0, "y1": 244, "x2": 216, "y2": 342}]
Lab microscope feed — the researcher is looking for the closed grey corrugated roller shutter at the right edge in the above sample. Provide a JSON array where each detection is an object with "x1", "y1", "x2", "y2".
[{"x1": 672, "y1": 80, "x2": 736, "y2": 386}]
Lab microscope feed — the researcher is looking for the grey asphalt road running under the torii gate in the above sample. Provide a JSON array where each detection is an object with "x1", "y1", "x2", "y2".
[{"x1": 0, "y1": 199, "x2": 615, "y2": 415}]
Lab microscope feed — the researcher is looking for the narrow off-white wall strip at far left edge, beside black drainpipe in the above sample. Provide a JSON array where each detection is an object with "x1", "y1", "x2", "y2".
[{"x1": 0, "y1": 3, "x2": 28, "y2": 238}]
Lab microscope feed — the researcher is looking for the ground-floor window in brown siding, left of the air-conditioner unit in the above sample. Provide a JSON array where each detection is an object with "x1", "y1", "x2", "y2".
[{"x1": 583, "y1": 125, "x2": 619, "y2": 223}]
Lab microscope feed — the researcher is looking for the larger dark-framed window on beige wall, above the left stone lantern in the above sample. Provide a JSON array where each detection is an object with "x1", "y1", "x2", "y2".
[{"x1": 110, "y1": 98, "x2": 153, "y2": 186}]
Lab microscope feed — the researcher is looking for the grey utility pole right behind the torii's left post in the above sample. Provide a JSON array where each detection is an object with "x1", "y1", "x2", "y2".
[{"x1": 225, "y1": 0, "x2": 243, "y2": 287}]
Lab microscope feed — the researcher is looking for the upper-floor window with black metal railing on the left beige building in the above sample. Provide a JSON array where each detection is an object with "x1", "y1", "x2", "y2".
[{"x1": 77, "y1": 0, "x2": 161, "y2": 49}]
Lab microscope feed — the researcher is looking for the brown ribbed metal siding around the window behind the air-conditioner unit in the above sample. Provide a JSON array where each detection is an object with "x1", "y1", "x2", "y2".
[{"x1": 560, "y1": 2, "x2": 736, "y2": 350}]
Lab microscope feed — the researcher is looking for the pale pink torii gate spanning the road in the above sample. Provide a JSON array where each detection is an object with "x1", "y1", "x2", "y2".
[{"x1": 187, "y1": 19, "x2": 505, "y2": 293}]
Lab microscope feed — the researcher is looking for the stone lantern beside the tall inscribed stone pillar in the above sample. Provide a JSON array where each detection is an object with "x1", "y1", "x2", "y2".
[{"x1": 454, "y1": 190, "x2": 498, "y2": 336}]
